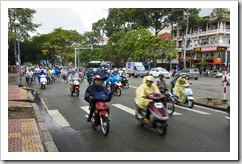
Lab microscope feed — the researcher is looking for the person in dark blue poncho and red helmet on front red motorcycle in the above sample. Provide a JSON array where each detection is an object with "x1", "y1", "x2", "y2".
[{"x1": 84, "y1": 75, "x2": 112, "y2": 122}]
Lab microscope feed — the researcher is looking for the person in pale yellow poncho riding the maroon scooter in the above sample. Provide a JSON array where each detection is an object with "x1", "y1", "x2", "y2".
[{"x1": 136, "y1": 76, "x2": 160, "y2": 123}]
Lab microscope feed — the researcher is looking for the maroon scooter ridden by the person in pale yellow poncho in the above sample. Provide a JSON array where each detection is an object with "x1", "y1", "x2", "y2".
[{"x1": 135, "y1": 93, "x2": 169, "y2": 136}]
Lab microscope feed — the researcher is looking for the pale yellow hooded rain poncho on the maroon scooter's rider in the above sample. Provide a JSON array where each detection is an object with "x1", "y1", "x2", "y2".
[{"x1": 136, "y1": 77, "x2": 160, "y2": 110}]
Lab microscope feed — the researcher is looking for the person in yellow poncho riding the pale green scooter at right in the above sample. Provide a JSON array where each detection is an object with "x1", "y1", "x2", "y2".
[{"x1": 174, "y1": 73, "x2": 188, "y2": 102}]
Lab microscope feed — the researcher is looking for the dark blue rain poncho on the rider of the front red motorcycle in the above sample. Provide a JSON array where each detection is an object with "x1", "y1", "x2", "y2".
[{"x1": 84, "y1": 84, "x2": 112, "y2": 102}]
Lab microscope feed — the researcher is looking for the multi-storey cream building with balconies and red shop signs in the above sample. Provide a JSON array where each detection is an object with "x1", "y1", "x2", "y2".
[{"x1": 172, "y1": 13, "x2": 230, "y2": 69}]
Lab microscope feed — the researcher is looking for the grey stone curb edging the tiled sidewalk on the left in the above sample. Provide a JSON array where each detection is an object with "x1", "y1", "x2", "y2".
[{"x1": 28, "y1": 92, "x2": 58, "y2": 152}]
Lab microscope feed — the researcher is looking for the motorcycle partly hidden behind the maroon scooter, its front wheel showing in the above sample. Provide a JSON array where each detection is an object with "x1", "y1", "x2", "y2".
[{"x1": 160, "y1": 89, "x2": 177, "y2": 116}]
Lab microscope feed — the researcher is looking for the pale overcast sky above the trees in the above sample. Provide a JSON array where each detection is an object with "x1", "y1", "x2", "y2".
[{"x1": 33, "y1": 8, "x2": 212, "y2": 34}]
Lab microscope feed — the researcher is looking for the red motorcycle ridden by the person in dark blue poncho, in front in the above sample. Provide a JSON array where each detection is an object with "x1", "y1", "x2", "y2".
[{"x1": 85, "y1": 102, "x2": 111, "y2": 136}]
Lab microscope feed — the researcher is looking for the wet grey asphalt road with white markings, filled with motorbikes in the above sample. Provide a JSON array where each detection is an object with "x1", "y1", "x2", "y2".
[{"x1": 8, "y1": 75, "x2": 230, "y2": 152}]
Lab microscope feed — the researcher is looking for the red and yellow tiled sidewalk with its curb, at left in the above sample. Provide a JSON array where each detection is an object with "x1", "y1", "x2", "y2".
[{"x1": 8, "y1": 82, "x2": 58, "y2": 152}]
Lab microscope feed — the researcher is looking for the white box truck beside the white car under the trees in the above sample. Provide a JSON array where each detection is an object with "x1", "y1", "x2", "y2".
[{"x1": 126, "y1": 62, "x2": 148, "y2": 78}]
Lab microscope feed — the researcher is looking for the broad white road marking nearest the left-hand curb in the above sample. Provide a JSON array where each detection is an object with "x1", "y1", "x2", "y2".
[{"x1": 48, "y1": 109, "x2": 70, "y2": 127}]
